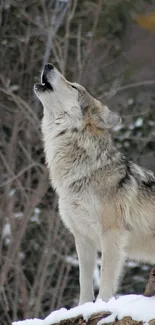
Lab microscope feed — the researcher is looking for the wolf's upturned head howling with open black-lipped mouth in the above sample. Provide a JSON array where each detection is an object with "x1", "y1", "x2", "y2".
[{"x1": 34, "y1": 64, "x2": 121, "y2": 134}]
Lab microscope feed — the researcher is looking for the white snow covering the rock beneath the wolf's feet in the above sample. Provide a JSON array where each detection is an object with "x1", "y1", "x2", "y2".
[{"x1": 12, "y1": 295, "x2": 155, "y2": 325}]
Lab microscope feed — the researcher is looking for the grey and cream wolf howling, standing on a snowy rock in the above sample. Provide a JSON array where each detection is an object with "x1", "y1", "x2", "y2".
[{"x1": 34, "y1": 64, "x2": 155, "y2": 304}]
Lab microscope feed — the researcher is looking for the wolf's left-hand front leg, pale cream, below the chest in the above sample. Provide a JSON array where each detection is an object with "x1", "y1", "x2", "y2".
[{"x1": 75, "y1": 236, "x2": 96, "y2": 305}]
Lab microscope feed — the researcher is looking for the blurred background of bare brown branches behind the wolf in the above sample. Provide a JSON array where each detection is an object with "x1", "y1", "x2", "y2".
[{"x1": 0, "y1": 0, "x2": 155, "y2": 325}]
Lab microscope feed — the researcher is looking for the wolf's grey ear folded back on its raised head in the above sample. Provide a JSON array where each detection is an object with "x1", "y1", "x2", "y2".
[{"x1": 97, "y1": 105, "x2": 122, "y2": 129}]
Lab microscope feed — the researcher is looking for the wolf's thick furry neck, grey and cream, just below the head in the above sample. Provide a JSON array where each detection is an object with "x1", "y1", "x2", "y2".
[{"x1": 43, "y1": 123, "x2": 121, "y2": 189}]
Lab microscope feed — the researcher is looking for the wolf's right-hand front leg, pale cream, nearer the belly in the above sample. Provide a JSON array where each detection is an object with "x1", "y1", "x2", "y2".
[{"x1": 98, "y1": 230, "x2": 127, "y2": 301}]
